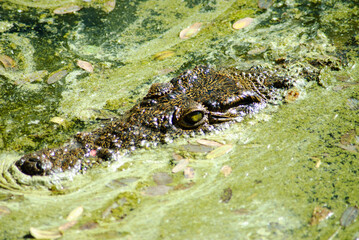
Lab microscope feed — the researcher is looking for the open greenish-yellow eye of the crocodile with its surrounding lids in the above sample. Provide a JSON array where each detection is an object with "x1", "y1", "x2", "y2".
[{"x1": 175, "y1": 103, "x2": 208, "y2": 129}]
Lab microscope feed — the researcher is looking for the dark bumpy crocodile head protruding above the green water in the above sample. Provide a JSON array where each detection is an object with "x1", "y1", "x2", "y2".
[{"x1": 16, "y1": 66, "x2": 290, "y2": 175}]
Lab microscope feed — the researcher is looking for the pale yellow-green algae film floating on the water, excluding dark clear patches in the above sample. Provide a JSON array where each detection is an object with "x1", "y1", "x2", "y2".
[{"x1": 0, "y1": 1, "x2": 359, "y2": 239}]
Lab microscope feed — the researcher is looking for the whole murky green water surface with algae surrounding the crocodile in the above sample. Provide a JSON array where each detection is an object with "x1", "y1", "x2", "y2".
[{"x1": 0, "y1": 0, "x2": 359, "y2": 239}]
